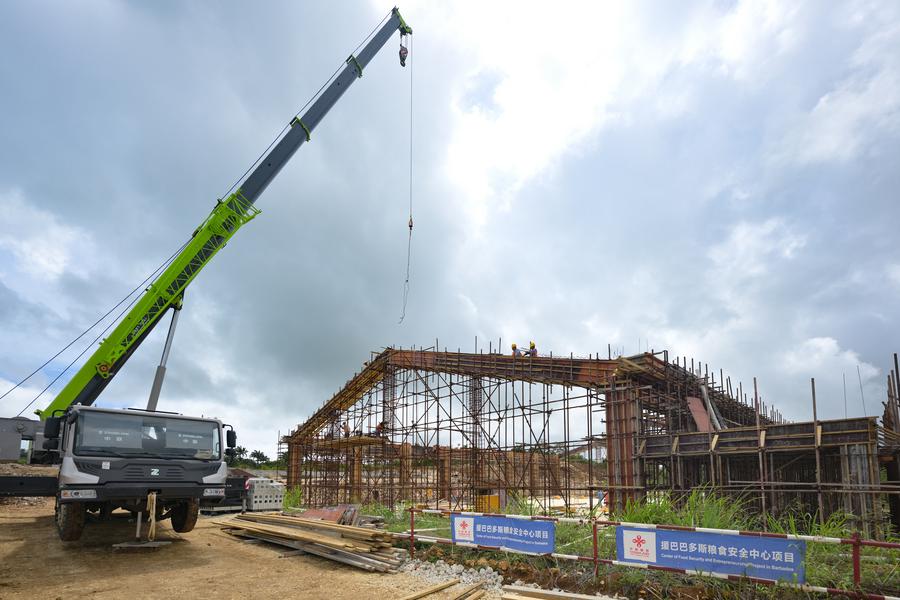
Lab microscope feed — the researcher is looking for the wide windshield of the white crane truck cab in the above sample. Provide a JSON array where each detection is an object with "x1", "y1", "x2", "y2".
[{"x1": 75, "y1": 411, "x2": 221, "y2": 460}]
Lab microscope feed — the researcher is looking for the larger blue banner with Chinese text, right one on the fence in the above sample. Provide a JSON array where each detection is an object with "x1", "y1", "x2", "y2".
[{"x1": 616, "y1": 527, "x2": 806, "y2": 583}]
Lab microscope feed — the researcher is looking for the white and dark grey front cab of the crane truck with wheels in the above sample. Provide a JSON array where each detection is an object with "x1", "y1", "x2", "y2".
[{"x1": 43, "y1": 404, "x2": 237, "y2": 541}]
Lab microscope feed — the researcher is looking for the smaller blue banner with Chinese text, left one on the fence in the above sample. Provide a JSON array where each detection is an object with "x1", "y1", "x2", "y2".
[{"x1": 450, "y1": 515, "x2": 556, "y2": 554}]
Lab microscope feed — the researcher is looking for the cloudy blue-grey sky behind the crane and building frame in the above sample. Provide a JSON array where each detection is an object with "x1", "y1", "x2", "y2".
[{"x1": 0, "y1": 0, "x2": 900, "y2": 453}]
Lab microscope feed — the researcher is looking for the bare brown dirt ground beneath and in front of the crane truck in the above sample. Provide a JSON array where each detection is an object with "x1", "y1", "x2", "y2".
[{"x1": 0, "y1": 498, "x2": 460, "y2": 600}]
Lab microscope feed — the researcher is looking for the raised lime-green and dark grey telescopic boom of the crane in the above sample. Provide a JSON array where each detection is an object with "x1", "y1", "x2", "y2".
[{"x1": 35, "y1": 8, "x2": 412, "y2": 420}]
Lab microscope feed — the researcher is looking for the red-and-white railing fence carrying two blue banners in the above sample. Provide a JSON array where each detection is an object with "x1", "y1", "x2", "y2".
[{"x1": 395, "y1": 508, "x2": 900, "y2": 600}]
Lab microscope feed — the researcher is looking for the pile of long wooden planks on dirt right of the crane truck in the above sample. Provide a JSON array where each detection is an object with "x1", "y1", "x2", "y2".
[{"x1": 216, "y1": 513, "x2": 406, "y2": 573}]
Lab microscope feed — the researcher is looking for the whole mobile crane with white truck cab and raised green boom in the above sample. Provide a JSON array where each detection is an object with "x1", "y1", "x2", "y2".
[{"x1": 0, "y1": 8, "x2": 412, "y2": 541}]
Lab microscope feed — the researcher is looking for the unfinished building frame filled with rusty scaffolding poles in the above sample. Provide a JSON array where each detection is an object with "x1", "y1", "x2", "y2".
[{"x1": 284, "y1": 348, "x2": 900, "y2": 535}]
